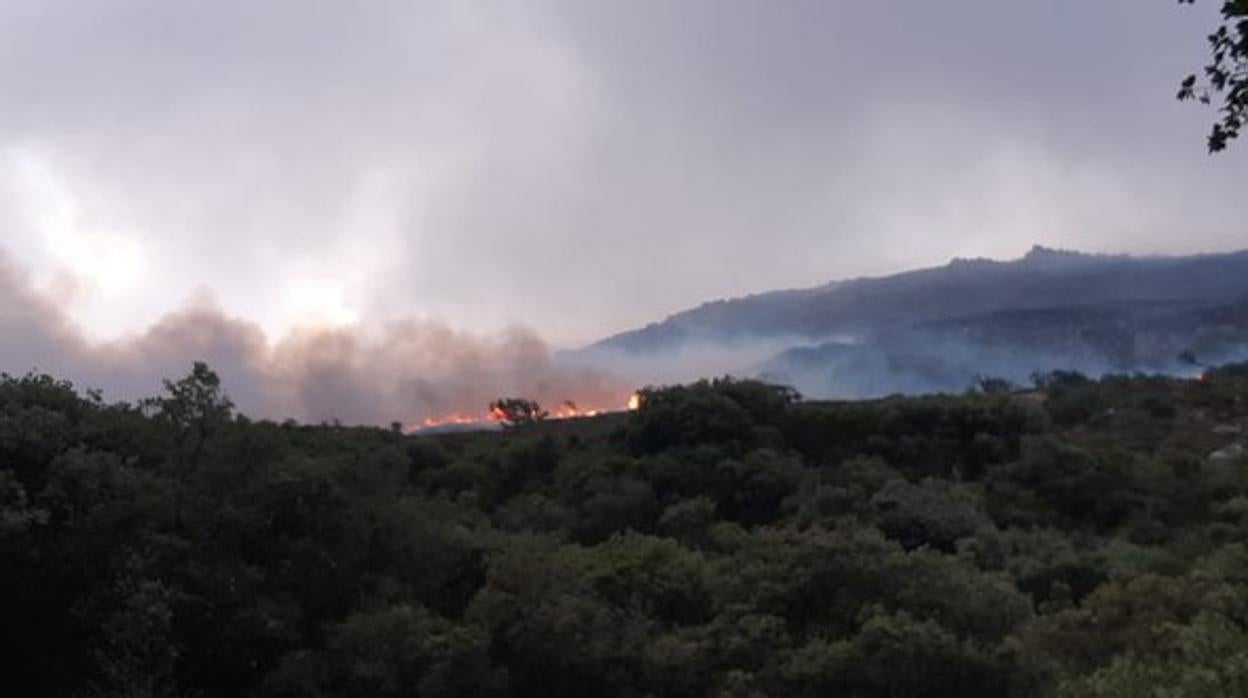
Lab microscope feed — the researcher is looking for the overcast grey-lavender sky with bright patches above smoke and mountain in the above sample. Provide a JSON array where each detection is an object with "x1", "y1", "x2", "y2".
[{"x1": 0, "y1": 0, "x2": 1248, "y2": 419}]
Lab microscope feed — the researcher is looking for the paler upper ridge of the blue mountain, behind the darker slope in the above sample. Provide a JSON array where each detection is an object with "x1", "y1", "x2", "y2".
[{"x1": 580, "y1": 245, "x2": 1248, "y2": 355}]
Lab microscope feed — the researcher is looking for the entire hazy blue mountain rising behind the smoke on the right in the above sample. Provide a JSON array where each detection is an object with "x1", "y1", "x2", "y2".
[{"x1": 574, "y1": 246, "x2": 1248, "y2": 397}]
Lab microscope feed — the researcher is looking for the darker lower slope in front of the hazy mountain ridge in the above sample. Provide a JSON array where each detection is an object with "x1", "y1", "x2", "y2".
[{"x1": 751, "y1": 301, "x2": 1248, "y2": 397}]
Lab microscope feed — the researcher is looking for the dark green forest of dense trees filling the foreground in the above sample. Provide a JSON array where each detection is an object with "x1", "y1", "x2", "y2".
[{"x1": 7, "y1": 365, "x2": 1248, "y2": 698}]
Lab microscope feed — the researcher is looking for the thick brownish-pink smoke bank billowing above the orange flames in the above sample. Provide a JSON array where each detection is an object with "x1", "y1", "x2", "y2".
[{"x1": 0, "y1": 250, "x2": 630, "y2": 425}]
